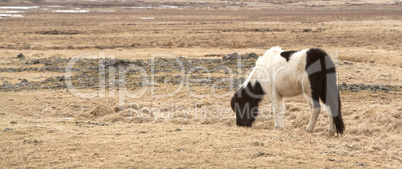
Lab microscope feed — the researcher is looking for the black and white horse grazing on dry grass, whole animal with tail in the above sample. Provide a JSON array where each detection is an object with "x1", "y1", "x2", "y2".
[{"x1": 231, "y1": 47, "x2": 345, "y2": 135}]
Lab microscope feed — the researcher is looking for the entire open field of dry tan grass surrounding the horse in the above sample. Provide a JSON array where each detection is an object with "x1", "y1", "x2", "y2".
[{"x1": 0, "y1": 0, "x2": 402, "y2": 168}]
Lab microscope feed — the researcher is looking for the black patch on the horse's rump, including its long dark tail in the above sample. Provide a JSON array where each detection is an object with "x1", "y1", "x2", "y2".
[{"x1": 306, "y1": 48, "x2": 345, "y2": 134}]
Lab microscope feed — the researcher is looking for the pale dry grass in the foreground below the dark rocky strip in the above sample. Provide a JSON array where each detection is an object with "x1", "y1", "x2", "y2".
[{"x1": 0, "y1": 91, "x2": 402, "y2": 168}]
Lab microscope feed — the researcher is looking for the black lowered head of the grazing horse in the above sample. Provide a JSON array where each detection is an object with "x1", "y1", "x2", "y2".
[{"x1": 230, "y1": 81, "x2": 264, "y2": 127}]
